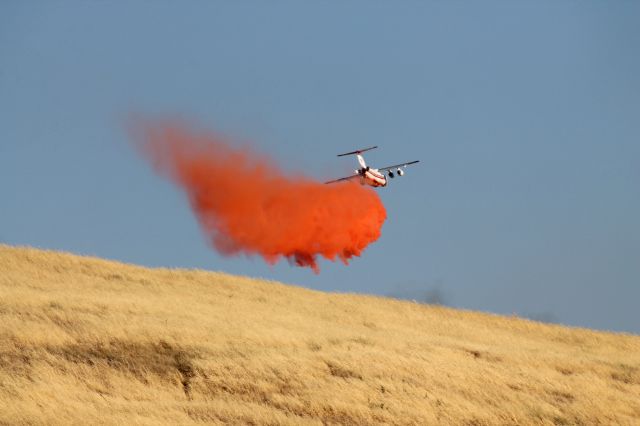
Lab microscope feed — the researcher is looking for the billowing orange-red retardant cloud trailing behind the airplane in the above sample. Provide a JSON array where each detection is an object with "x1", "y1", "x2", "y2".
[{"x1": 142, "y1": 125, "x2": 386, "y2": 273}]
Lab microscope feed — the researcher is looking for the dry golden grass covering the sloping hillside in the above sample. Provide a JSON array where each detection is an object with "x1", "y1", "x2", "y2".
[{"x1": 0, "y1": 245, "x2": 640, "y2": 425}]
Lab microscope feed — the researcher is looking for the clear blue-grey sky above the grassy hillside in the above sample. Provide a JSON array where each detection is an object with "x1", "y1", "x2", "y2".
[{"x1": 0, "y1": 0, "x2": 640, "y2": 333}]
